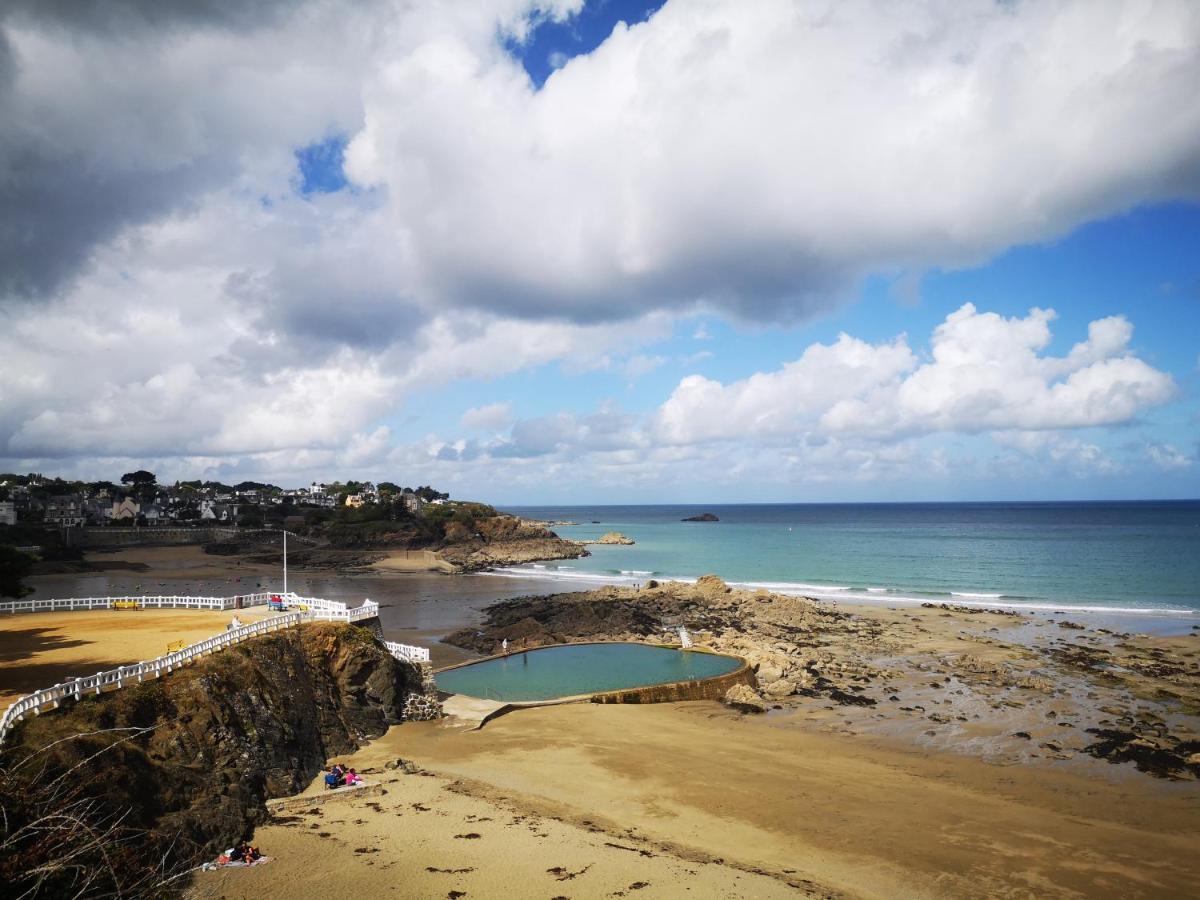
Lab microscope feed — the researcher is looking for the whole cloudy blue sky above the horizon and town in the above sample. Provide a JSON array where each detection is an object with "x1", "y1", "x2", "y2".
[{"x1": 0, "y1": 0, "x2": 1200, "y2": 505}]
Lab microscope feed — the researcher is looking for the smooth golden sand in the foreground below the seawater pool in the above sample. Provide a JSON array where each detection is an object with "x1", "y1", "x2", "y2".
[{"x1": 193, "y1": 703, "x2": 1200, "y2": 898}]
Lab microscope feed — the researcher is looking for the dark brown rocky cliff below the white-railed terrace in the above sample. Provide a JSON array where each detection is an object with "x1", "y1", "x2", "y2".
[{"x1": 0, "y1": 623, "x2": 421, "y2": 897}]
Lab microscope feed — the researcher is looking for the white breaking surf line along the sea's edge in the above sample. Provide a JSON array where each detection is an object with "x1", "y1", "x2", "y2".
[{"x1": 480, "y1": 565, "x2": 1200, "y2": 619}]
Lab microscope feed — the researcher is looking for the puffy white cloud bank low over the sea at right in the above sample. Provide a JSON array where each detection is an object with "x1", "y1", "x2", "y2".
[{"x1": 654, "y1": 304, "x2": 1175, "y2": 443}]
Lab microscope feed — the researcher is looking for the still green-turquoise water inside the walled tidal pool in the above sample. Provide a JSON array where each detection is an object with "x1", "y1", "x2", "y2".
[{"x1": 437, "y1": 643, "x2": 742, "y2": 701}]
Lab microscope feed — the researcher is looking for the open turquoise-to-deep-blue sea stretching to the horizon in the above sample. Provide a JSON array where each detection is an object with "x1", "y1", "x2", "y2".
[{"x1": 500, "y1": 500, "x2": 1200, "y2": 618}]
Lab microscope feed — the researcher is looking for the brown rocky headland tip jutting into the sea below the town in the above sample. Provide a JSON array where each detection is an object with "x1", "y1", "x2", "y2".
[{"x1": 438, "y1": 516, "x2": 588, "y2": 571}]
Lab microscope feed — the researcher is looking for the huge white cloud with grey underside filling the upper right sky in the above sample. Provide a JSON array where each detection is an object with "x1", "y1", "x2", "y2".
[{"x1": 347, "y1": 0, "x2": 1200, "y2": 317}]
